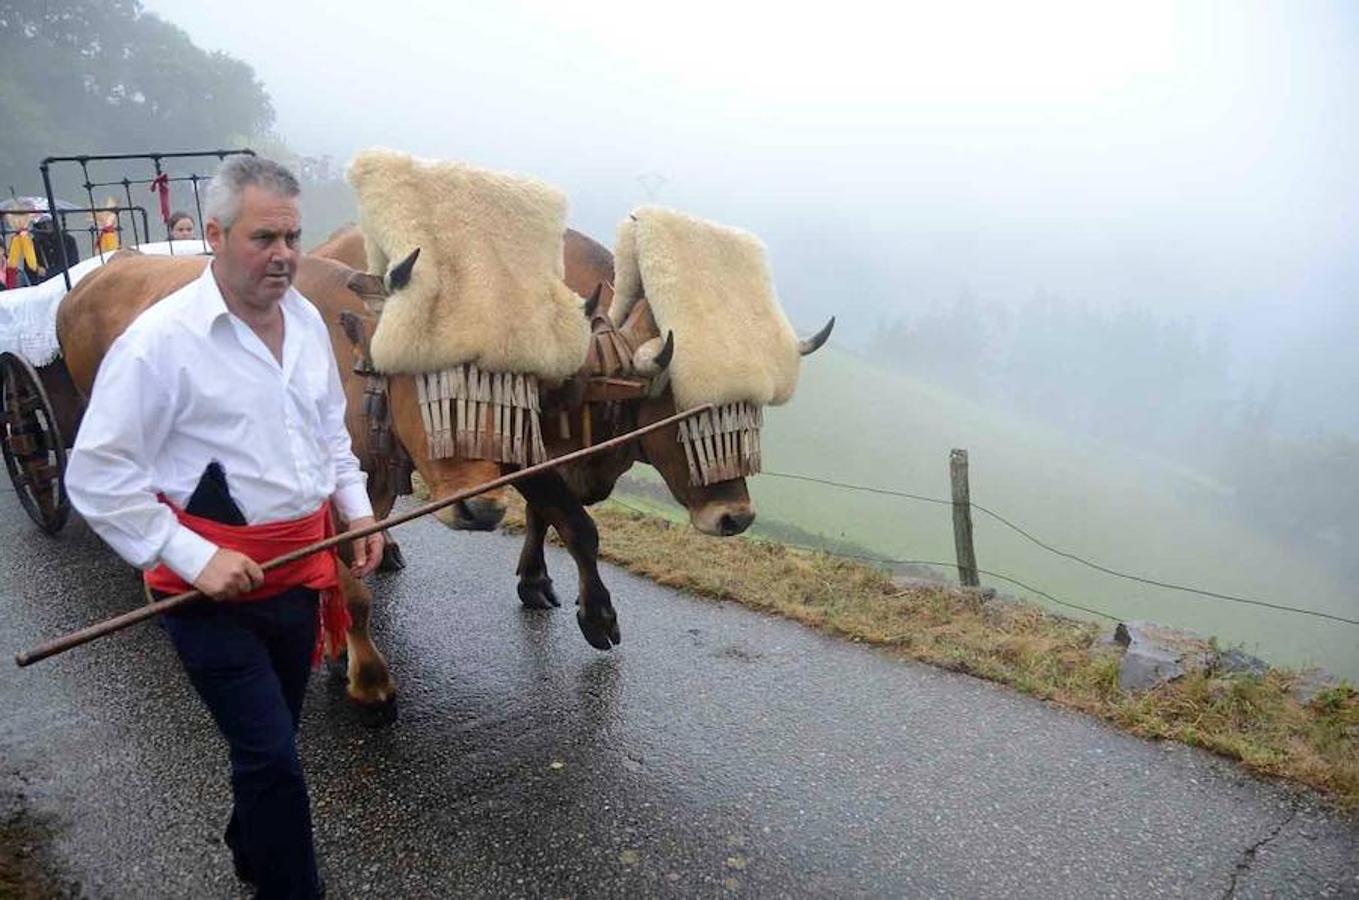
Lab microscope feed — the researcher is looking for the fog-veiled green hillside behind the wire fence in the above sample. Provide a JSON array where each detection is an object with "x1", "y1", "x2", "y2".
[{"x1": 622, "y1": 348, "x2": 1359, "y2": 678}]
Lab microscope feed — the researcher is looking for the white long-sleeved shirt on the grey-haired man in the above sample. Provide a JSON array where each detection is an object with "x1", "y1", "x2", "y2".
[{"x1": 65, "y1": 265, "x2": 372, "y2": 582}]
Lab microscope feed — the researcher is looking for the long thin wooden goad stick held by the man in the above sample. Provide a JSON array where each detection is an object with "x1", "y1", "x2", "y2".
[{"x1": 14, "y1": 404, "x2": 712, "y2": 668}]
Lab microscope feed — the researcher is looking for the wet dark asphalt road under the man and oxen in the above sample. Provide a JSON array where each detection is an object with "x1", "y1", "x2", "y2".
[{"x1": 0, "y1": 491, "x2": 1359, "y2": 897}]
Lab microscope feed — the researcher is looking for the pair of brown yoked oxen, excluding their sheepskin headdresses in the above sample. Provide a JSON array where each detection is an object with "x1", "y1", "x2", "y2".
[{"x1": 57, "y1": 221, "x2": 833, "y2": 711}]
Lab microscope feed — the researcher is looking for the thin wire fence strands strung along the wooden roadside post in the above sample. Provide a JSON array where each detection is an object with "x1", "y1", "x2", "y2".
[{"x1": 613, "y1": 469, "x2": 1359, "y2": 625}]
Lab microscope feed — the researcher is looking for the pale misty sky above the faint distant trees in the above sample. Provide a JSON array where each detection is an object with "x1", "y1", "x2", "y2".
[{"x1": 144, "y1": 0, "x2": 1359, "y2": 424}]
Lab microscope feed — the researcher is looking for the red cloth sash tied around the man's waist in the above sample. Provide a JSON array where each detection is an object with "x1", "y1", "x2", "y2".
[{"x1": 145, "y1": 496, "x2": 352, "y2": 663}]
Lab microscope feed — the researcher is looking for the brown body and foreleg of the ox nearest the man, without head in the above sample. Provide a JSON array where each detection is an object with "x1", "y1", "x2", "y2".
[{"x1": 57, "y1": 252, "x2": 402, "y2": 714}]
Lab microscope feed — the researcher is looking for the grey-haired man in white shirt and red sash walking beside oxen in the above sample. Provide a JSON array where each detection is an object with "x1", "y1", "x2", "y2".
[{"x1": 67, "y1": 156, "x2": 382, "y2": 897}]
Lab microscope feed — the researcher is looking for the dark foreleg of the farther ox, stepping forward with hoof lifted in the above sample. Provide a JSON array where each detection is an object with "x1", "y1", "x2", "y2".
[{"x1": 515, "y1": 472, "x2": 621, "y2": 650}]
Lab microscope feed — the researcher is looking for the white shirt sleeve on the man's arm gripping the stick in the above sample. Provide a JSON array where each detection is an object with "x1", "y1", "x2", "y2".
[{"x1": 65, "y1": 339, "x2": 217, "y2": 583}]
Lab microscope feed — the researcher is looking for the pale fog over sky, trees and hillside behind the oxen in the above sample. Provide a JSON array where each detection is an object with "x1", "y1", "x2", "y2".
[{"x1": 0, "y1": 0, "x2": 1359, "y2": 672}]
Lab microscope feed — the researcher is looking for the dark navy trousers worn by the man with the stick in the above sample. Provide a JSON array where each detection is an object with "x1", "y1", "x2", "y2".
[{"x1": 163, "y1": 589, "x2": 321, "y2": 899}]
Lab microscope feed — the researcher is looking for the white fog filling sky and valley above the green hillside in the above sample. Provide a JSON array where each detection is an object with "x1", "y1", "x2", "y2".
[{"x1": 129, "y1": 0, "x2": 1359, "y2": 633}]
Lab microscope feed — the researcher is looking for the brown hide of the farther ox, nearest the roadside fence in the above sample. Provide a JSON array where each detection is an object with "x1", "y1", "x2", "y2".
[{"x1": 313, "y1": 226, "x2": 754, "y2": 650}]
